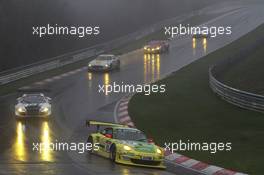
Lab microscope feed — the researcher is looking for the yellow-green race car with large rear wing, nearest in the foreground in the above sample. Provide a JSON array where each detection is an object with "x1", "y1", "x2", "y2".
[{"x1": 86, "y1": 121, "x2": 166, "y2": 168}]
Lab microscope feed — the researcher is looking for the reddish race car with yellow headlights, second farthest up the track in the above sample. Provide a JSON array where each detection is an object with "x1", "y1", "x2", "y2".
[{"x1": 144, "y1": 40, "x2": 170, "y2": 54}]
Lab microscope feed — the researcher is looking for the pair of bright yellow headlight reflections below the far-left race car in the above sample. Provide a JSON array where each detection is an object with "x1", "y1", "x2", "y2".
[{"x1": 12, "y1": 120, "x2": 53, "y2": 162}]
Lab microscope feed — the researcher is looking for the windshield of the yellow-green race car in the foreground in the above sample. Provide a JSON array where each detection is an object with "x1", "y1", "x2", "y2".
[{"x1": 114, "y1": 129, "x2": 147, "y2": 142}]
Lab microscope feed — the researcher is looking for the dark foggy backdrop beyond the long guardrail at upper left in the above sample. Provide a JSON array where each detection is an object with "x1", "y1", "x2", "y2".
[{"x1": 0, "y1": 0, "x2": 217, "y2": 71}]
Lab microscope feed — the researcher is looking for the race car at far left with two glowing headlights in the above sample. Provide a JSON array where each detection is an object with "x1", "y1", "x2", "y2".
[{"x1": 15, "y1": 93, "x2": 51, "y2": 118}]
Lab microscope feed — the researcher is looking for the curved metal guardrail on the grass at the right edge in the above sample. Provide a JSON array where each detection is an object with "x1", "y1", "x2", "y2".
[{"x1": 209, "y1": 66, "x2": 264, "y2": 112}]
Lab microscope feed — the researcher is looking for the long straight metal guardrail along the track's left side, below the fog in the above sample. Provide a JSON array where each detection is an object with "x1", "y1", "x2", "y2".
[{"x1": 0, "y1": 13, "x2": 195, "y2": 85}]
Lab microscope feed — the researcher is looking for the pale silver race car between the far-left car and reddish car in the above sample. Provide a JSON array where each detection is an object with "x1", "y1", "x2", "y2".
[{"x1": 88, "y1": 55, "x2": 120, "y2": 71}]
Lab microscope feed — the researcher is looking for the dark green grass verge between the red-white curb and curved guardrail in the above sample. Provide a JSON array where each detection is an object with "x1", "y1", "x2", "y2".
[{"x1": 129, "y1": 25, "x2": 264, "y2": 174}]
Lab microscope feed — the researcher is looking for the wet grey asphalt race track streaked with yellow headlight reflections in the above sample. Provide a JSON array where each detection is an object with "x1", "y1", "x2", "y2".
[{"x1": 0, "y1": 2, "x2": 264, "y2": 175}]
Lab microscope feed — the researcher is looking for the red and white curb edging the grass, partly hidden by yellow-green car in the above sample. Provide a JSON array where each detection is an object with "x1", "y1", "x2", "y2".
[{"x1": 114, "y1": 95, "x2": 246, "y2": 175}]
